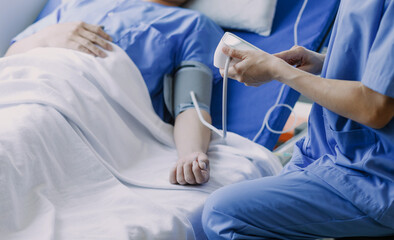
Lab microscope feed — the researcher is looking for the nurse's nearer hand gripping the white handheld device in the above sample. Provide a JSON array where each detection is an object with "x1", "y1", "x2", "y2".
[{"x1": 220, "y1": 47, "x2": 286, "y2": 87}]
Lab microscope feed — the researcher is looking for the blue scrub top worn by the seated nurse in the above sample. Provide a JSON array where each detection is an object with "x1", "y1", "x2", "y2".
[{"x1": 285, "y1": 0, "x2": 394, "y2": 228}]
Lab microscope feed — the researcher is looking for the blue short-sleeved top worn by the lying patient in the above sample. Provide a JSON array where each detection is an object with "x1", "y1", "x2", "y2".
[{"x1": 13, "y1": 0, "x2": 223, "y2": 121}]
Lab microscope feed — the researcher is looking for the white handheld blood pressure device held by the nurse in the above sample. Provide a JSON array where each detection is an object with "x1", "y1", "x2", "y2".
[{"x1": 213, "y1": 32, "x2": 260, "y2": 68}]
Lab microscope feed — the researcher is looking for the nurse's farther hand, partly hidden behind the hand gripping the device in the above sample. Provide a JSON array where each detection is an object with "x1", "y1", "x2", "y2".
[{"x1": 274, "y1": 46, "x2": 326, "y2": 75}]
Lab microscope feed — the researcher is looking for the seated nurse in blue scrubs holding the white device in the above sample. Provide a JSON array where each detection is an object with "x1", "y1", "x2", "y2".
[{"x1": 202, "y1": 0, "x2": 394, "y2": 239}]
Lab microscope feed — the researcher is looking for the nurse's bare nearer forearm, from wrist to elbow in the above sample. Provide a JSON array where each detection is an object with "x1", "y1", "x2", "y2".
[{"x1": 276, "y1": 62, "x2": 394, "y2": 128}]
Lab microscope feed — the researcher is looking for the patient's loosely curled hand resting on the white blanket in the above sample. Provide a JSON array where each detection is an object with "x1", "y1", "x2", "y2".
[{"x1": 170, "y1": 152, "x2": 209, "y2": 185}]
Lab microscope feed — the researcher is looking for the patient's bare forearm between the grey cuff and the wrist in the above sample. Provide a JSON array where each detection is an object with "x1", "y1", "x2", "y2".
[{"x1": 174, "y1": 109, "x2": 211, "y2": 157}]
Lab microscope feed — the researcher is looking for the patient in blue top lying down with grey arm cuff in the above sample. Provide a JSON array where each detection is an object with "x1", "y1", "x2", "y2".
[{"x1": 6, "y1": 0, "x2": 223, "y2": 184}]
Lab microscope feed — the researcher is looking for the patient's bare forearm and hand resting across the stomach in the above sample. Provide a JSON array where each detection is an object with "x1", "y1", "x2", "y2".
[{"x1": 6, "y1": 22, "x2": 112, "y2": 57}]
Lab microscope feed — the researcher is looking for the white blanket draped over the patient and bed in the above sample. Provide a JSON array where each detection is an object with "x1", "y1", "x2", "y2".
[{"x1": 0, "y1": 45, "x2": 281, "y2": 240}]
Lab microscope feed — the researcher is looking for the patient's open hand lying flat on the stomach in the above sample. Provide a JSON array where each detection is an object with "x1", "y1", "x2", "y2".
[{"x1": 37, "y1": 22, "x2": 112, "y2": 57}]
